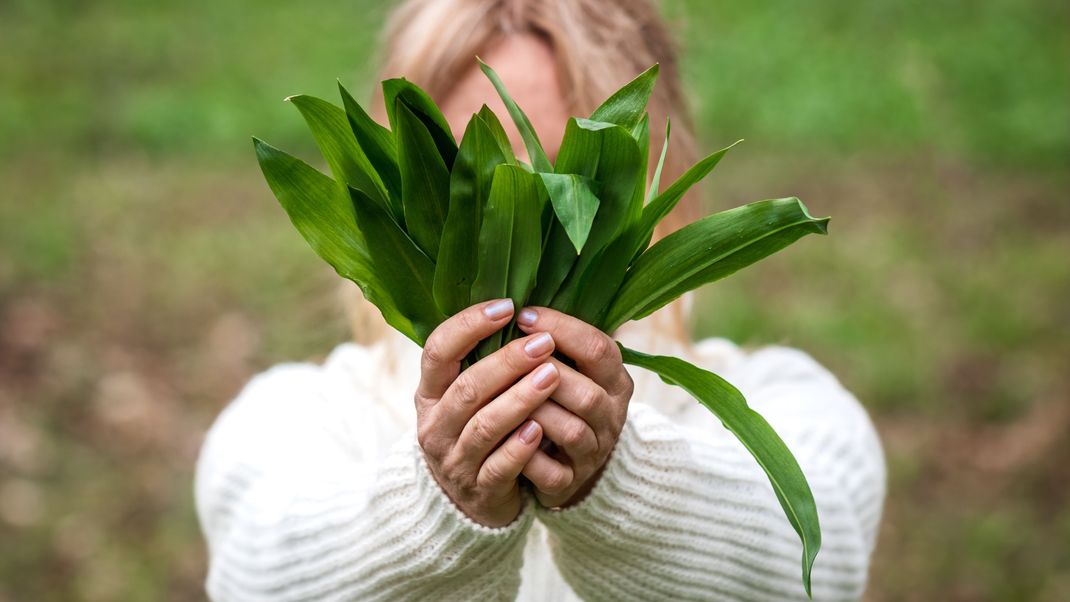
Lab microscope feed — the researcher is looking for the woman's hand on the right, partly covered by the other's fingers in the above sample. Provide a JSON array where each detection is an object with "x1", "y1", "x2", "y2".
[{"x1": 517, "y1": 307, "x2": 633, "y2": 508}]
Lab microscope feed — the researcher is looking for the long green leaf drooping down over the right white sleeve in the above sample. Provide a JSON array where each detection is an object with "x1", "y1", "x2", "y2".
[{"x1": 620, "y1": 345, "x2": 821, "y2": 597}]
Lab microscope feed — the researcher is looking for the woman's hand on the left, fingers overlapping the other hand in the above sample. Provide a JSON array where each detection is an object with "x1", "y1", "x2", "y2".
[{"x1": 415, "y1": 299, "x2": 560, "y2": 527}]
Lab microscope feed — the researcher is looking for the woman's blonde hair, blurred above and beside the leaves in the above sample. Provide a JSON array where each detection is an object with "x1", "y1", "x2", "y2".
[{"x1": 350, "y1": 0, "x2": 700, "y2": 340}]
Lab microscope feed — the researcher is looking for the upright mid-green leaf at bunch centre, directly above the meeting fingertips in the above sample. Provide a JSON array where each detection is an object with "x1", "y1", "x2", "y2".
[{"x1": 472, "y1": 165, "x2": 544, "y2": 357}]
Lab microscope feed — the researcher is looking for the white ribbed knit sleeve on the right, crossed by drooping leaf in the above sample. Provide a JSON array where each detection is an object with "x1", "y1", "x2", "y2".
[{"x1": 537, "y1": 349, "x2": 885, "y2": 601}]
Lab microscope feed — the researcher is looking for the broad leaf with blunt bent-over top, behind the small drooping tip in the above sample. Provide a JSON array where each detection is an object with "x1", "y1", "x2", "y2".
[{"x1": 551, "y1": 119, "x2": 645, "y2": 313}]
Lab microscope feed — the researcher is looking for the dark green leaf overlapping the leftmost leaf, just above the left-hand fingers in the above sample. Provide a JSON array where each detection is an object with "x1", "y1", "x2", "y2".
[{"x1": 349, "y1": 187, "x2": 446, "y2": 345}]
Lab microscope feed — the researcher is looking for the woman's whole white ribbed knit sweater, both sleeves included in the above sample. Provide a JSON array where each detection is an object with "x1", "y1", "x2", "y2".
[{"x1": 196, "y1": 323, "x2": 885, "y2": 602}]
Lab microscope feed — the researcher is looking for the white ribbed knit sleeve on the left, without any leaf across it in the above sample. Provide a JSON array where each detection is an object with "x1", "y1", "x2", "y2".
[{"x1": 196, "y1": 366, "x2": 534, "y2": 601}]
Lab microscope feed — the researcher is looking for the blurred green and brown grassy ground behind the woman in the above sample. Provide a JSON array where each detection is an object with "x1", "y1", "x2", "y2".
[{"x1": 0, "y1": 0, "x2": 1070, "y2": 602}]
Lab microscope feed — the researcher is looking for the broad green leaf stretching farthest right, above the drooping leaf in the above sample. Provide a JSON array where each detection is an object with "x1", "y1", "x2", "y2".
[{"x1": 603, "y1": 197, "x2": 828, "y2": 333}]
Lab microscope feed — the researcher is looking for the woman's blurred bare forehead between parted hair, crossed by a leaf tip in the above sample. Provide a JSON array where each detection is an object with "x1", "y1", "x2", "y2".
[{"x1": 440, "y1": 33, "x2": 569, "y2": 157}]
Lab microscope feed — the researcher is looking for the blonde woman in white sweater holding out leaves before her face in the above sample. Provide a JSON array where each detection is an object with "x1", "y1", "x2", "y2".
[{"x1": 196, "y1": 0, "x2": 885, "y2": 600}]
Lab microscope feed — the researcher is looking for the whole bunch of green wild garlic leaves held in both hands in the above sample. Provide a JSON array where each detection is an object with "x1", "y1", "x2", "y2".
[{"x1": 254, "y1": 62, "x2": 828, "y2": 593}]
